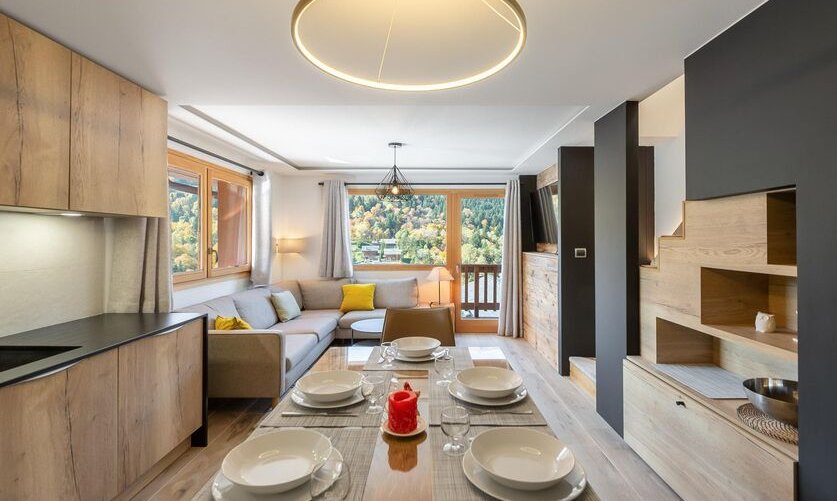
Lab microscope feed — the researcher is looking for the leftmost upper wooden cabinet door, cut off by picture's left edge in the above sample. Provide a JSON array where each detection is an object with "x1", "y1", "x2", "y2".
[{"x1": 0, "y1": 15, "x2": 71, "y2": 209}]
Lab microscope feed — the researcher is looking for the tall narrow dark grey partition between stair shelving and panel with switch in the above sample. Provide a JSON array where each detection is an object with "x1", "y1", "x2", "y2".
[{"x1": 594, "y1": 101, "x2": 639, "y2": 435}]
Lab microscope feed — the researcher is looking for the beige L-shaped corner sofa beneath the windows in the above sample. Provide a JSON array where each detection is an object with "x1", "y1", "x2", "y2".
[{"x1": 178, "y1": 278, "x2": 418, "y2": 400}]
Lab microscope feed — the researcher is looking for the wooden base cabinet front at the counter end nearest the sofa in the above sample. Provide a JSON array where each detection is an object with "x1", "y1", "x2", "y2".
[{"x1": 119, "y1": 322, "x2": 203, "y2": 491}]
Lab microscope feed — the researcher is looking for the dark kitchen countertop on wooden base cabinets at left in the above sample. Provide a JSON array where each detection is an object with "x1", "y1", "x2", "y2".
[{"x1": 0, "y1": 313, "x2": 206, "y2": 387}]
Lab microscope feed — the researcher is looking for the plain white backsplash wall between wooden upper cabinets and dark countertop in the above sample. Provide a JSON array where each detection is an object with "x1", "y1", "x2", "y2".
[{"x1": 0, "y1": 212, "x2": 106, "y2": 336}]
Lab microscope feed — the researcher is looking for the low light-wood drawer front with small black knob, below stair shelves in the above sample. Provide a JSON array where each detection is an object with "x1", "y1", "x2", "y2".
[{"x1": 623, "y1": 361, "x2": 796, "y2": 501}]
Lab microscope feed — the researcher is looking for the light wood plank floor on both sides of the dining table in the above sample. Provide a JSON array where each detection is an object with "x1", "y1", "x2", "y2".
[{"x1": 134, "y1": 334, "x2": 679, "y2": 501}]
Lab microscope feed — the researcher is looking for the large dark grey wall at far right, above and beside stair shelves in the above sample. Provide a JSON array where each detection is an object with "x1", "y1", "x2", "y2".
[{"x1": 686, "y1": 0, "x2": 837, "y2": 501}]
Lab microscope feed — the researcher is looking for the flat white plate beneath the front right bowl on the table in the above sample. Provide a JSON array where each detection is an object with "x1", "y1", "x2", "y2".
[{"x1": 462, "y1": 450, "x2": 587, "y2": 501}]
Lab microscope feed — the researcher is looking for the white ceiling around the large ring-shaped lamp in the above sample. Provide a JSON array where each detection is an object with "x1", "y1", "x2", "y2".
[{"x1": 0, "y1": 0, "x2": 763, "y2": 172}]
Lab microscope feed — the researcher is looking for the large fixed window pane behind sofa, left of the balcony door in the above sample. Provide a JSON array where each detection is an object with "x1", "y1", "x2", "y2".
[{"x1": 349, "y1": 191, "x2": 448, "y2": 269}]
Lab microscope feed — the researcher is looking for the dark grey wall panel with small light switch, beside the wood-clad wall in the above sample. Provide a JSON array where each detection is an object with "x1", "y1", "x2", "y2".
[{"x1": 558, "y1": 146, "x2": 596, "y2": 376}]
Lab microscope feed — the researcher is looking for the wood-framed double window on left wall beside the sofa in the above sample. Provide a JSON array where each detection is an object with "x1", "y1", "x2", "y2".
[{"x1": 168, "y1": 151, "x2": 252, "y2": 283}]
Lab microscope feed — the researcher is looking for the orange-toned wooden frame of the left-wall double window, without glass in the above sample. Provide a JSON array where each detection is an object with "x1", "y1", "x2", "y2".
[{"x1": 166, "y1": 149, "x2": 253, "y2": 285}]
